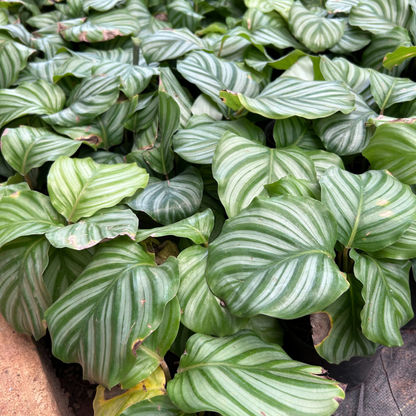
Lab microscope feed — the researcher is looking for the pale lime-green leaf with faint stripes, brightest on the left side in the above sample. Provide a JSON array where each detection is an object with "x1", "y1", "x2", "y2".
[{"x1": 48, "y1": 156, "x2": 149, "y2": 222}]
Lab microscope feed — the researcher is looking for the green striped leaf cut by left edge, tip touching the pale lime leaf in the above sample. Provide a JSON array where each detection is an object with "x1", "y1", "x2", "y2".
[{"x1": 0, "y1": 191, "x2": 64, "y2": 247}]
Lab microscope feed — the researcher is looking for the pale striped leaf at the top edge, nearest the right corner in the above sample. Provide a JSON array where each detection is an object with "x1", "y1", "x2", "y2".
[{"x1": 349, "y1": 0, "x2": 410, "y2": 35}]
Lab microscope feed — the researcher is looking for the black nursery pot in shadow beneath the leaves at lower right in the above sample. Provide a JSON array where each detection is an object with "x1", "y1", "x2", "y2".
[{"x1": 281, "y1": 317, "x2": 384, "y2": 390}]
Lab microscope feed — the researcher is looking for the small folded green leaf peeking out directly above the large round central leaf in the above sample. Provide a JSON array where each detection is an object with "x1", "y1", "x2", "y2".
[{"x1": 264, "y1": 175, "x2": 321, "y2": 201}]
